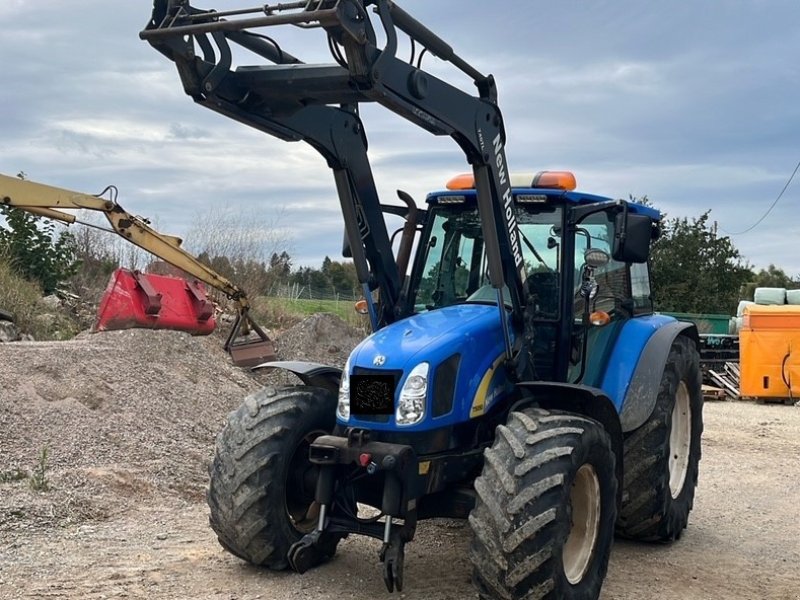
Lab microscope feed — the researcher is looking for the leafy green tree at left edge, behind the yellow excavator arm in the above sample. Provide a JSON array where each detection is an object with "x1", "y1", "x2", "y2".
[{"x1": 0, "y1": 206, "x2": 80, "y2": 294}]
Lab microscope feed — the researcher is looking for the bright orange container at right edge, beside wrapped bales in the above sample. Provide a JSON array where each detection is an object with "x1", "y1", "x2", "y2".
[{"x1": 739, "y1": 305, "x2": 800, "y2": 398}]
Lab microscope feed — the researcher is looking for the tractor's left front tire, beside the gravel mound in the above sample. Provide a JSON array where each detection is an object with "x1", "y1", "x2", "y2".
[{"x1": 207, "y1": 386, "x2": 338, "y2": 570}]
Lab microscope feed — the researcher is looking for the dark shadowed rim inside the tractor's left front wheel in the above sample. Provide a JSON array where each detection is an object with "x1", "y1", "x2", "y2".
[{"x1": 285, "y1": 431, "x2": 326, "y2": 534}]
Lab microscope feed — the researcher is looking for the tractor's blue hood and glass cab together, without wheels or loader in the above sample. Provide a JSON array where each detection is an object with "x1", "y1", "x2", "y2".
[{"x1": 337, "y1": 172, "x2": 659, "y2": 436}]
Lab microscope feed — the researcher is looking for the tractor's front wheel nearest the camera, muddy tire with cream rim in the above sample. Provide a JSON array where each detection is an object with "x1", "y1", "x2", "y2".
[{"x1": 469, "y1": 409, "x2": 617, "y2": 600}]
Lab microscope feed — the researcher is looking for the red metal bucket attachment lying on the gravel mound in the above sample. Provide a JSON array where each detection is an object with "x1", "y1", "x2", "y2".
[{"x1": 94, "y1": 269, "x2": 216, "y2": 335}]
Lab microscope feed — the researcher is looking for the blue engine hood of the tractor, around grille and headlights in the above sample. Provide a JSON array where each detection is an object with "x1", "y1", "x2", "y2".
[{"x1": 339, "y1": 304, "x2": 509, "y2": 431}]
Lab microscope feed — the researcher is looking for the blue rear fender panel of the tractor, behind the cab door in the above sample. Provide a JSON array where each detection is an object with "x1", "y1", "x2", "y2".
[{"x1": 600, "y1": 315, "x2": 675, "y2": 412}]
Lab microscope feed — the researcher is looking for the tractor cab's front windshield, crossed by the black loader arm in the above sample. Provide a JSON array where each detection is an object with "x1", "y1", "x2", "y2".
[{"x1": 414, "y1": 205, "x2": 562, "y2": 318}]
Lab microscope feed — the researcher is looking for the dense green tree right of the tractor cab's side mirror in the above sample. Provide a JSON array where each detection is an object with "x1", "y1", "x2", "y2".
[{"x1": 645, "y1": 210, "x2": 753, "y2": 314}]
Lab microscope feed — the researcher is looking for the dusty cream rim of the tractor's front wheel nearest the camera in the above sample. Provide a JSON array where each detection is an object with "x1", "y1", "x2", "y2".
[{"x1": 562, "y1": 465, "x2": 600, "y2": 585}]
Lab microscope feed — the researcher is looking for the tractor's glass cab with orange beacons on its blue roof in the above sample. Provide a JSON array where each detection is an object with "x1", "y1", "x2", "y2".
[{"x1": 408, "y1": 172, "x2": 659, "y2": 386}]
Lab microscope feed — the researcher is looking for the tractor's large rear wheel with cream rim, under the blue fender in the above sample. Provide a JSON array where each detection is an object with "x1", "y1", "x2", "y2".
[{"x1": 617, "y1": 336, "x2": 703, "y2": 542}]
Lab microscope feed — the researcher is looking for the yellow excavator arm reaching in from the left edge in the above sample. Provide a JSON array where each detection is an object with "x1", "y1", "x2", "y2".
[{"x1": 0, "y1": 174, "x2": 274, "y2": 366}]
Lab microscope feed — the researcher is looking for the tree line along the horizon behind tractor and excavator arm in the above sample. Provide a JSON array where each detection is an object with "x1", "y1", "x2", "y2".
[{"x1": 0, "y1": 198, "x2": 800, "y2": 314}]
